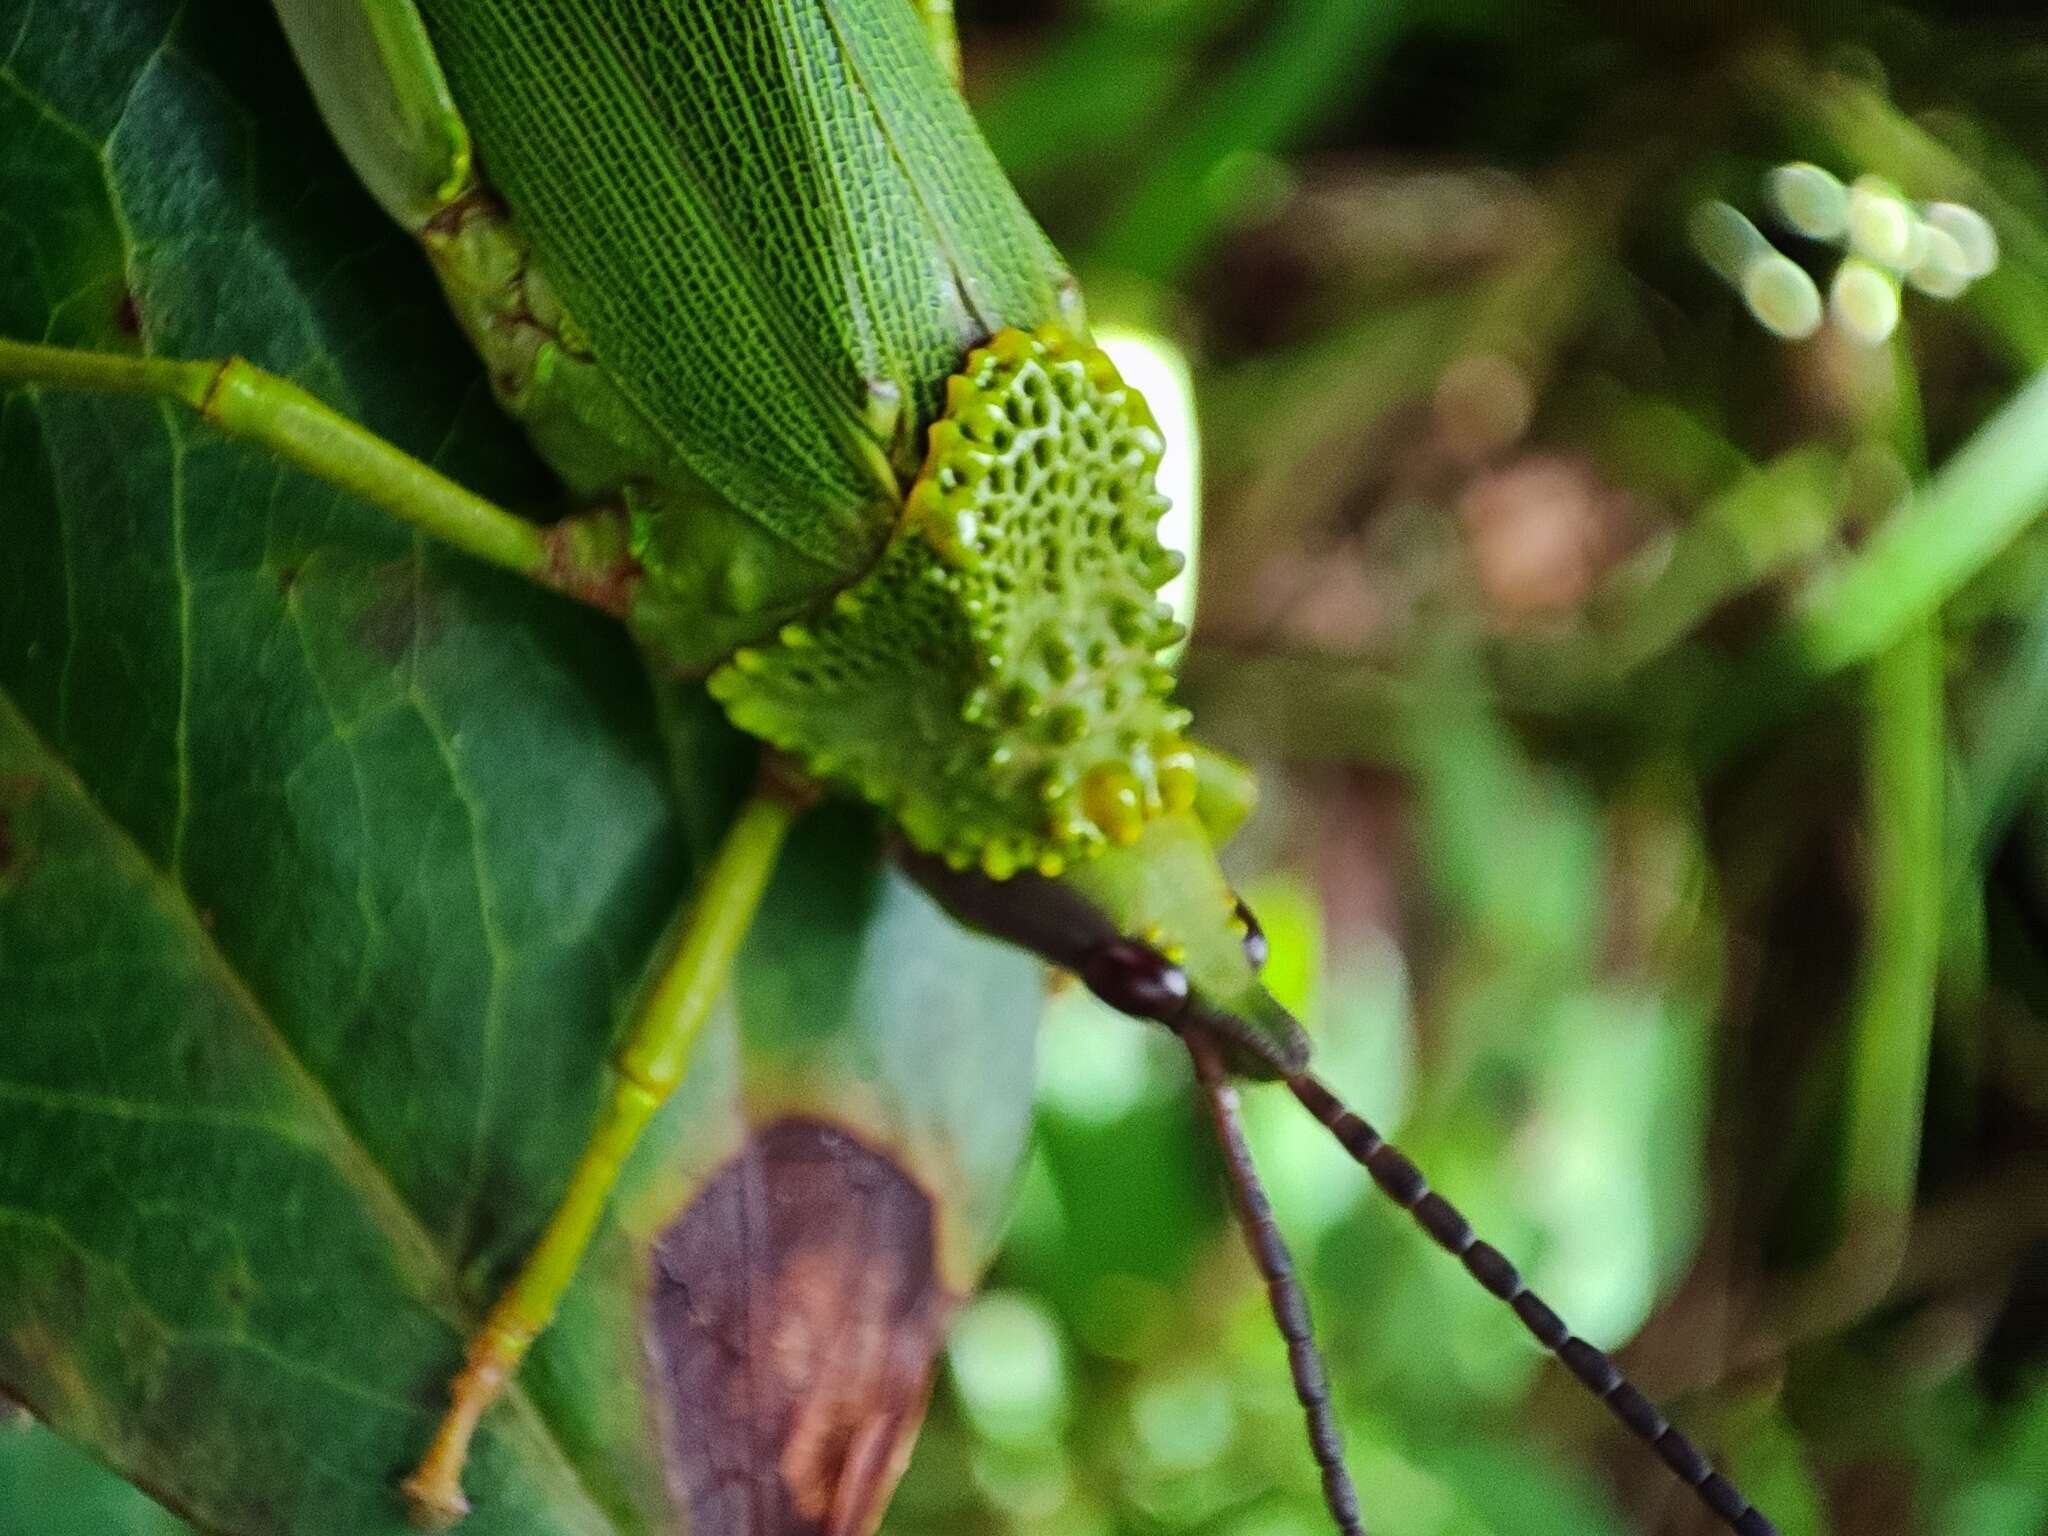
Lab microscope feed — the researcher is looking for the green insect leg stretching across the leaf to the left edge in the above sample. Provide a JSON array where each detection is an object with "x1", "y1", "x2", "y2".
[{"x1": 0, "y1": 340, "x2": 629, "y2": 612}]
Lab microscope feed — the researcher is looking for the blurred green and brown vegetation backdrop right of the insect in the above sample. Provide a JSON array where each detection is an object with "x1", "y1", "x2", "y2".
[{"x1": 887, "y1": 0, "x2": 2048, "y2": 1536}]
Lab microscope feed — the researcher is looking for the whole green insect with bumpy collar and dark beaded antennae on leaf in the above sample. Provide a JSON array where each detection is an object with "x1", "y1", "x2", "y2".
[{"x1": 0, "y1": 0, "x2": 1774, "y2": 1536}]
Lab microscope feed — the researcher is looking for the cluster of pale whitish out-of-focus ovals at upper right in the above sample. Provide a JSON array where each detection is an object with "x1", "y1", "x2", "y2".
[{"x1": 1692, "y1": 162, "x2": 1999, "y2": 346}]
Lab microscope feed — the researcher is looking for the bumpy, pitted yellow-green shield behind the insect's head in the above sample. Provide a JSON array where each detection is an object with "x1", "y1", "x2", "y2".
[{"x1": 711, "y1": 326, "x2": 1196, "y2": 879}]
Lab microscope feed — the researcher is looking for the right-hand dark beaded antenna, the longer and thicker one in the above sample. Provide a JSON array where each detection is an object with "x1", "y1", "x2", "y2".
[{"x1": 1276, "y1": 1073, "x2": 1778, "y2": 1536}]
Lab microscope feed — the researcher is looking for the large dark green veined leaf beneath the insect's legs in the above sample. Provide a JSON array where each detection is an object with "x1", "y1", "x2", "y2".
[{"x1": 0, "y1": 0, "x2": 1038, "y2": 1536}]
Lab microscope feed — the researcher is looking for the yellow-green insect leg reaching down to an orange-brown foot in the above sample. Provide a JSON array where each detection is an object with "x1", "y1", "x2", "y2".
[{"x1": 406, "y1": 778, "x2": 803, "y2": 1528}]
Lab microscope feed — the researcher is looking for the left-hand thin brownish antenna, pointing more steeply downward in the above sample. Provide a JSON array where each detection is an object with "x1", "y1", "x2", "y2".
[{"x1": 1182, "y1": 1028, "x2": 1366, "y2": 1536}]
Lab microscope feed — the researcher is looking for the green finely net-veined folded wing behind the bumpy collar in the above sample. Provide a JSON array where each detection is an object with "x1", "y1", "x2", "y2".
[{"x1": 407, "y1": 0, "x2": 1067, "y2": 573}]
